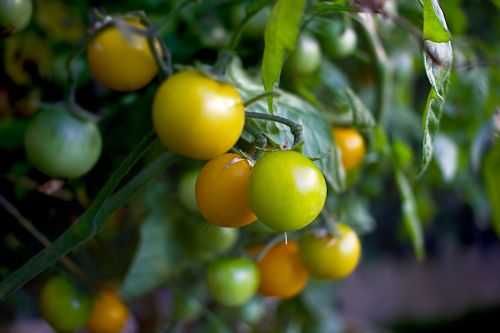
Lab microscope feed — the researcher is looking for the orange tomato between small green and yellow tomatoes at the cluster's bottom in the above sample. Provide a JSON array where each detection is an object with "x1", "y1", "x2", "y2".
[{"x1": 251, "y1": 240, "x2": 309, "y2": 298}]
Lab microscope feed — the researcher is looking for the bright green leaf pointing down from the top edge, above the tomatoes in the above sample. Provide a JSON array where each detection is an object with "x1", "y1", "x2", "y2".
[{"x1": 262, "y1": 0, "x2": 306, "y2": 91}]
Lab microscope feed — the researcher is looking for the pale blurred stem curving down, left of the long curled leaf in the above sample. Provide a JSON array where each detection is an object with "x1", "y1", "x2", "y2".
[{"x1": 355, "y1": 15, "x2": 392, "y2": 127}]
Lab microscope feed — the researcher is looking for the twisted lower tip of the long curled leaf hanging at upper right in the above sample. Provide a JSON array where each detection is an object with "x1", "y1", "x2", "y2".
[{"x1": 419, "y1": 88, "x2": 444, "y2": 176}]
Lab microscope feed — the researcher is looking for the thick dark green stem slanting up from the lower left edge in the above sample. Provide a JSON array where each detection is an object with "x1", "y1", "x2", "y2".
[{"x1": 0, "y1": 132, "x2": 160, "y2": 300}]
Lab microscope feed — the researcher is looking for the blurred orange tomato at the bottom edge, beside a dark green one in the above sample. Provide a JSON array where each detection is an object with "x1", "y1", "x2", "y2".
[{"x1": 87, "y1": 290, "x2": 128, "y2": 333}]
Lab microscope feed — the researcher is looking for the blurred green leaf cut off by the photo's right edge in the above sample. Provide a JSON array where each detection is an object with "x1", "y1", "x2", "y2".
[{"x1": 482, "y1": 139, "x2": 500, "y2": 237}]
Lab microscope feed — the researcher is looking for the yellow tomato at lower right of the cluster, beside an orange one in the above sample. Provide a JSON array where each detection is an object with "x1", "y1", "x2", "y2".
[{"x1": 299, "y1": 223, "x2": 361, "y2": 280}]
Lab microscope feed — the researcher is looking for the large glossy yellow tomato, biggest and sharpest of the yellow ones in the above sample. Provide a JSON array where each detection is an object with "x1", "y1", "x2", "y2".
[{"x1": 153, "y1": 70, "x2": 245, "y2": 160}]
